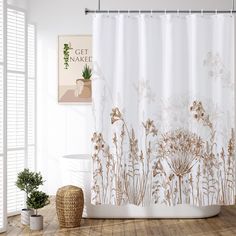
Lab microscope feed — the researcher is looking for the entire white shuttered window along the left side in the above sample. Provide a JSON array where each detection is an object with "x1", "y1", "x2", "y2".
[{"x1": 0, "y1": 0, "x2": 36, "y2": 232}]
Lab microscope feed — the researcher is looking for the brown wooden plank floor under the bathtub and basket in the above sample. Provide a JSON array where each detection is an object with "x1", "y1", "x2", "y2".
[{"x1": 0, "y1": 197, "x2": 236, "y2": 236}]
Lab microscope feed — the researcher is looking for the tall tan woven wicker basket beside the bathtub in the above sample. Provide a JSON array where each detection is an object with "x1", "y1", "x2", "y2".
[{"x1": 56, "y1": 185, "x2": 84, "y2": 228}]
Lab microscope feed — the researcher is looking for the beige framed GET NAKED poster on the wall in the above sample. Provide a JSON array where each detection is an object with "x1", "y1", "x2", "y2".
[{"x1": 58, "y1": 35, "x2": 92, "y2": 103}]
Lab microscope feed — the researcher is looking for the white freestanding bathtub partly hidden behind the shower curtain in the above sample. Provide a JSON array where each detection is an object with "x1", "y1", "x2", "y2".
[{"x1": 60, "y1": 154, "x2": 220, "y2": 218}]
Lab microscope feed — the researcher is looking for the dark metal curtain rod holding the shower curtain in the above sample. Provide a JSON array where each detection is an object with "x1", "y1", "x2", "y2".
[{"x1": 84, "y1": 8, "x2": 236, "y2": 15}]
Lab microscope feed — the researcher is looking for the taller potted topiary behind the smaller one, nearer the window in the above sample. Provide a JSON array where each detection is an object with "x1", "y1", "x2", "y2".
[{"x1": 16, "y1": 169, "x2": 43, "y2": 225}]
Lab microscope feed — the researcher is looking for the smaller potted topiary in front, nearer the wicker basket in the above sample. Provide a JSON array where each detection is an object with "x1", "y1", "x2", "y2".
[{"x1": 27, "y1": 191, "x2": 50, "y2": 230}]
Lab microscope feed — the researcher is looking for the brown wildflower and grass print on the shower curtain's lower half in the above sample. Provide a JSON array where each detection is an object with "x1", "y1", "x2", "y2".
[{"x1": 92, "y1": 101, "x2": 235, "y2": 206}]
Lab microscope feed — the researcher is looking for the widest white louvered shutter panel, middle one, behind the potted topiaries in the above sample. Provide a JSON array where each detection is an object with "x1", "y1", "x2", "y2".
[{"x1": 7, "y1": 8, "x2": 27, "y2": 215}]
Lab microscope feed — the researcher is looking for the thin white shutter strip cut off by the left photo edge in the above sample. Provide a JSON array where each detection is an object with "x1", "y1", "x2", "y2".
[{"x1": 0, "y1": 0, "x2": 7, "y2": 233}]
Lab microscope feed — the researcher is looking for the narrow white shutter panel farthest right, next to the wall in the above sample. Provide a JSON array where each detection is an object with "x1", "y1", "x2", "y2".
[{"x1": 27, "y1": 24, "x2": 36, "y2": 171}]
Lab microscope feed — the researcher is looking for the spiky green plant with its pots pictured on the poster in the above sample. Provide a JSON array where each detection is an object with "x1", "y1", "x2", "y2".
[{"x1": 75, "y1": 64, "x2": 92, "y2": 97}]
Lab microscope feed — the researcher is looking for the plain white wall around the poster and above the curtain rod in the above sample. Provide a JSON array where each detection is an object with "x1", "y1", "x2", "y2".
[{"x1": 27, "y1": 0, "x2": 236, "y2": 194}]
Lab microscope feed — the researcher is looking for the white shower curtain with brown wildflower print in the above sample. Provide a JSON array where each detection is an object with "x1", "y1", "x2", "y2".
[{"x1": 91, "y1": 14, "x2": 235, "y2": 206}]
